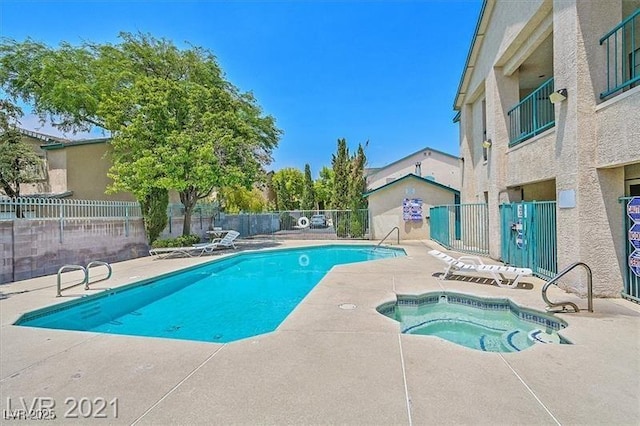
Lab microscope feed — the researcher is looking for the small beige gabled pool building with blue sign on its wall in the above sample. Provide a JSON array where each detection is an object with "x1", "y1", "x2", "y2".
[{"x1": 364, "y1": 173, "x2": 460, "y2": 241}]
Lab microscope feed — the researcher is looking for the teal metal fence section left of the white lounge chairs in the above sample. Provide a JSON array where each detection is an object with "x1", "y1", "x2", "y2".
[{"x1": 429, "y1": 204, "x2": 489, "y2": 255}]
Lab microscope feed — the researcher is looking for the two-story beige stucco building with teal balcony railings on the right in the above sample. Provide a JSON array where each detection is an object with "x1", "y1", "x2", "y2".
[{"x1": 454, "y1": 0, "x2": 640, "y2": 301}]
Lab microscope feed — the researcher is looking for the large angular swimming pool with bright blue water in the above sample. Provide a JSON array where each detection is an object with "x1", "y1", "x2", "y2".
[{"x1": 16, "y1": 245, "x2": 405, "y2": 342}]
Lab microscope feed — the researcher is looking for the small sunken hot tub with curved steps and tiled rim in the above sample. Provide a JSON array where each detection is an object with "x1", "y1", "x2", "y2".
[{"x1": 378, "y1": 292, "x2": 569, "y2": 352}]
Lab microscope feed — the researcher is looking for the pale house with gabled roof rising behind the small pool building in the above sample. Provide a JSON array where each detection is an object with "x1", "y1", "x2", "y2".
[{"x1": 365, "y1": 147, "x2": 461, "y2": 191}]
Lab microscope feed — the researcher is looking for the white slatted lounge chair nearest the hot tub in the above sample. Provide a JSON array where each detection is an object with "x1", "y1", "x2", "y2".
[{"x1": 429, "y1": 250, "x2": 533, "y2": 288}]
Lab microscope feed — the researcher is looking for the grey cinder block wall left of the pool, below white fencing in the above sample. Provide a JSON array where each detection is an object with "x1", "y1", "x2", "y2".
[{"x1": 0, "y1": 219, "x2": 149, "y2": 283}]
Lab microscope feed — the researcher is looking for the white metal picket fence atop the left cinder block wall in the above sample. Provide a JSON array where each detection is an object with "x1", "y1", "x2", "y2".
[{"x1": 0, "y1": 197, "x2": 142, "y2": 219}]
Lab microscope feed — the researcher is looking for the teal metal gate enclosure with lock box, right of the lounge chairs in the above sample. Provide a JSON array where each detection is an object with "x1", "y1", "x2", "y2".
[{"x1": 500, "y1": 201, "x2": 558, "y2": 279}]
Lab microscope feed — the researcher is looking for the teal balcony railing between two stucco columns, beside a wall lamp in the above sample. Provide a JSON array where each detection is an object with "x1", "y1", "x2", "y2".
[{"x1": 507, "y1": 78, "x2": 556, "y2": 146}]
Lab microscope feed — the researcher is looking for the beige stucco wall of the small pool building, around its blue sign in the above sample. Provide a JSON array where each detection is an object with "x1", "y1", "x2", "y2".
[{"x1": 369, "y1": 178, "x2": 454, "y2": 240}]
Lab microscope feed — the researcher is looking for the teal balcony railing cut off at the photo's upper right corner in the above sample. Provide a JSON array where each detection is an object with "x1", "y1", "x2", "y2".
[{"x1": 600, "y1": 9, "x2": 640, "y2": 99}]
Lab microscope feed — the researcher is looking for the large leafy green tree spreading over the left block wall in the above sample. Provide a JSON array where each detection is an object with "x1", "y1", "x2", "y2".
[{"x1": 0, "y1": 33, "x2": 281, "y2": 240}]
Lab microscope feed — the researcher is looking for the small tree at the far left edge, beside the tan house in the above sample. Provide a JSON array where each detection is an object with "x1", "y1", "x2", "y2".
[{"x1": 0, "y1": 99, "x2": 40, "y2": 205}]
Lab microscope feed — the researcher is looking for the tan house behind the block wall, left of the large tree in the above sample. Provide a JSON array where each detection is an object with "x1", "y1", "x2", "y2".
[{"x1": 14, "y1": 130, "x2": 134, "y2": 201}]
